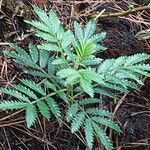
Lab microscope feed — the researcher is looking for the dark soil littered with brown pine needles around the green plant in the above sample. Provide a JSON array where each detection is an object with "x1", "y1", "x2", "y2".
[{"x1": 0, "y1": 0, "x2": 150, "y2": 150}]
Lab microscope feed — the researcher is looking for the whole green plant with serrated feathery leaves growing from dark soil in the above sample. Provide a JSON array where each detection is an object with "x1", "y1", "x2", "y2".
[{"x1": 0, "y1": 6, "x2": 150, "y2": 150}]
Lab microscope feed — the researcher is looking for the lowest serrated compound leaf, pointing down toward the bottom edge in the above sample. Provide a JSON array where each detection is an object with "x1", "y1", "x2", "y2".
[{"x1": 66, "y1": 98, "x2": 121, "y2": 149}]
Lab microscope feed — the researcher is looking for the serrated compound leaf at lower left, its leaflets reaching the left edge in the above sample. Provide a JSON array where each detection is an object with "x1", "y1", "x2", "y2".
[{"x1": 0, "y1": 79, "x2": 61, "y2": 127}]
